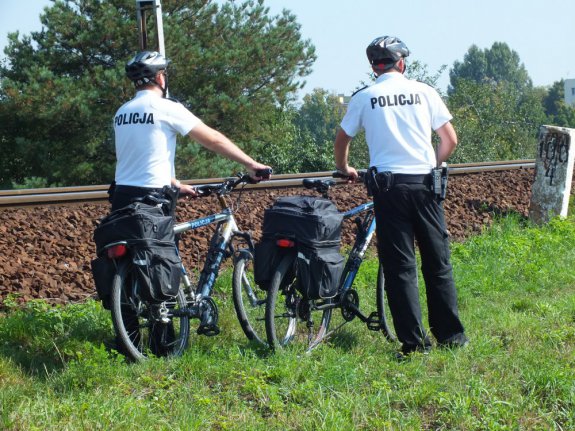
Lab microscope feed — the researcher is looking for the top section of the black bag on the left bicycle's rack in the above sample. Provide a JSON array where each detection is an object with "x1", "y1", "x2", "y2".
[{"x1": 94, "y1": 202, "x2": 174, "y2": 255}]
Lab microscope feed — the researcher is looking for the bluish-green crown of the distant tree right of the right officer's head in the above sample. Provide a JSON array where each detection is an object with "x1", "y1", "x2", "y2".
[{"x1": 448, "y1": 42, "x2": 533, "y2": 94}]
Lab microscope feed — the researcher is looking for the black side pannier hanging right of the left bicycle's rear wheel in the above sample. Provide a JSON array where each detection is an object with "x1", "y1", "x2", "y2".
[{"x1": 132, "y1": 240, "x2": 182, "y2": 301}]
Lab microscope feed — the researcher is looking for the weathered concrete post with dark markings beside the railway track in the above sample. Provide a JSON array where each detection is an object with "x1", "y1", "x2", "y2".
[{"x1": 529, "y1": 126, "x2": 575, "y2": 224}]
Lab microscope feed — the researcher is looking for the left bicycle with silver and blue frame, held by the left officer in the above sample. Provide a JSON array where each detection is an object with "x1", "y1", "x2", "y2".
[{"x1": 100, "y1": 171, "x2": 271, "y2": 361}]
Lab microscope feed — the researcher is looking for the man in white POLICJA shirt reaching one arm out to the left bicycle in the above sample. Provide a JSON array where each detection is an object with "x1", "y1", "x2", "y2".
[{"x1": 111, "y1": 51, "x2": 269, "y2": 210}]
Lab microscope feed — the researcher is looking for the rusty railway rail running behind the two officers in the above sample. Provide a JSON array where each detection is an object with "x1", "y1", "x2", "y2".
[{"x1": 0, "y1": 159, "x2": 535, "y2": 209}]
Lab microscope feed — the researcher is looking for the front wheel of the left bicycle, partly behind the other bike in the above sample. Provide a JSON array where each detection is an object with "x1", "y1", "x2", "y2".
[{"x1": 232, "y1": 250, "x2": 267, "y2": 346}]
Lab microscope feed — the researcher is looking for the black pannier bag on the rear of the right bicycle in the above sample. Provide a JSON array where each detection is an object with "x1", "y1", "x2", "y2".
[{"x1": 254, "y1": 196, "x2": 345, "y2": 299}]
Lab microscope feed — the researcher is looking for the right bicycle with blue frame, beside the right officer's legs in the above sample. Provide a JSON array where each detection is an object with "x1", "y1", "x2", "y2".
[{"x1": 265, "y1": 172, "x2": 396, "y2": 352}]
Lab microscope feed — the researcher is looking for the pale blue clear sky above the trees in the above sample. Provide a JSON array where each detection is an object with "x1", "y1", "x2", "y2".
[{"x1": 0, "y1": 0, "x2": 575, "y2": 97}]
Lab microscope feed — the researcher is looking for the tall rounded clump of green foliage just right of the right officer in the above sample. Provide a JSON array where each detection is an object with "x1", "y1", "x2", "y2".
[{"x1": 448, "y1": 42, "x2": 546, "y2": 163}]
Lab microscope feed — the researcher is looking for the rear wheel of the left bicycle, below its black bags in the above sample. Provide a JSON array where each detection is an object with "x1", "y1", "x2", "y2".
[{"x1": 111, "y1": 262, "x2": 190, "y2": 361}]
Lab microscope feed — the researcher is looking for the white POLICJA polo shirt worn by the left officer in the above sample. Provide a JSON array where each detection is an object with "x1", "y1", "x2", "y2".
[{"x1": 114, "y1": 90, "x2": 201, "y2": 188}]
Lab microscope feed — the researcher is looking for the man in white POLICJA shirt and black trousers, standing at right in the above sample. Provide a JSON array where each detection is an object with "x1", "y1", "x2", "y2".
[{"x1": 334, "y1": 36, "x2": 468, "y2": 359}]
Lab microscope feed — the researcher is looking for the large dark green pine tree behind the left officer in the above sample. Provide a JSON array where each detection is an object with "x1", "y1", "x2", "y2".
[{"x1": 0, "y1": 0, "x2": 315, "y2": 187}]
